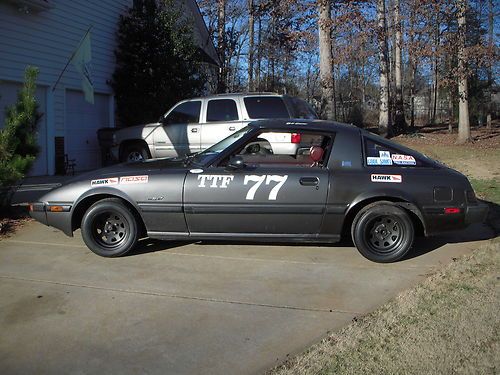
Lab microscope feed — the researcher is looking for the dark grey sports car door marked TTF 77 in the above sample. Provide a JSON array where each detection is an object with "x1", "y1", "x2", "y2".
[{"x1": 184, "y1": 135, "x2": 329, "y2": 237}]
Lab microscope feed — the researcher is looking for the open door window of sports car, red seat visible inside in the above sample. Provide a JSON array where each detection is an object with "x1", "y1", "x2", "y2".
[{"x1": 225, "y1": 132, "x2": 333, "y2": 168}]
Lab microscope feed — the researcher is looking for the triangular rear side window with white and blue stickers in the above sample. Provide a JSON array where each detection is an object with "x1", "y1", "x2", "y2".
[{"x1": 365, "y1": 138, "x2": 427, "y2": 167}]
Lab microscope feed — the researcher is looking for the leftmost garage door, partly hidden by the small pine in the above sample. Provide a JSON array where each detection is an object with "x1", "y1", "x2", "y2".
[{"x1": 0, "y1": 81, "x2": 47, "y2": 176}]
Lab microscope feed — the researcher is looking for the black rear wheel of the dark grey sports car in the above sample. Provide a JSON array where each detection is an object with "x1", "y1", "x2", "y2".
[{"x1": 351, "y1": 202, "x2": 415, "y2": 263}]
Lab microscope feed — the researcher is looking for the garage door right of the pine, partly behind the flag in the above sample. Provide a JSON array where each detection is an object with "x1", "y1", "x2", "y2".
[{"x1": 64, "y1": 90, "x2": 109, "y2": 171}]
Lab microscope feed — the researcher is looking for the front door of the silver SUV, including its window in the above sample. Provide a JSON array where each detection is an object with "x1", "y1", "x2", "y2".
[{"x1": 153, "y1": 100, "x2": 201, "y2": 157}]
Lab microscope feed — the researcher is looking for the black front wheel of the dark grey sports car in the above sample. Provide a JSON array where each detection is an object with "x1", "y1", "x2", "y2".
[{"x1": 81, "y1": 198, "x2": 139, "y2": 257}]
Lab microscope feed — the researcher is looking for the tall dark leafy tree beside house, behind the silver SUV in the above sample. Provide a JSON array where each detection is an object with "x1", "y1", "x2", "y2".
[{"x1": 112, "y1": 0, "x2": 205, "y2": 126}]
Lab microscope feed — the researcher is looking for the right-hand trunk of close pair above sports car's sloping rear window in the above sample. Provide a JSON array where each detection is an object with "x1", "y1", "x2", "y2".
[{"x1": 394, "y1": 0, "x2": 406, "y2": 133}]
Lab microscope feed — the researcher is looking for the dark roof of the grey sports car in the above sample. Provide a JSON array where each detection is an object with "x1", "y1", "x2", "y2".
[{"x1": 249, "y1": 119, "x2": 360, "y2": 132}]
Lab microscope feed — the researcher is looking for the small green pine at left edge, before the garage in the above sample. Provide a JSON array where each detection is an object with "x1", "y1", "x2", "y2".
[{"x1": 0, "y1": 66, "x2": 41, "y2": 186}]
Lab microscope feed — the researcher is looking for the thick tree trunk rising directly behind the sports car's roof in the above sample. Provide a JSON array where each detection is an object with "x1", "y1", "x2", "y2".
[{"x1": 318, "y1": 0, "x2": 334, "y2": 120}]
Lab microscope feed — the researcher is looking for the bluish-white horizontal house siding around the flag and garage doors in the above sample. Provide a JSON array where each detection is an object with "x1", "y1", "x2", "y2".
[{"x1": 0, "y1": 0, "x2": 132, "y2": 174}]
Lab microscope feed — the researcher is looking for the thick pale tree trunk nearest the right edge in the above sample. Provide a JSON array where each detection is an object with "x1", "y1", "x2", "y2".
[{"x1": 457, "y1": 0, "x2": 471, "y2": 143}]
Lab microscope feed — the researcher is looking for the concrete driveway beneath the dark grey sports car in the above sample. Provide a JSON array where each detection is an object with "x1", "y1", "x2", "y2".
[{"x1": 0, "y1": 222, "x2": 493, "y2": 374}]
